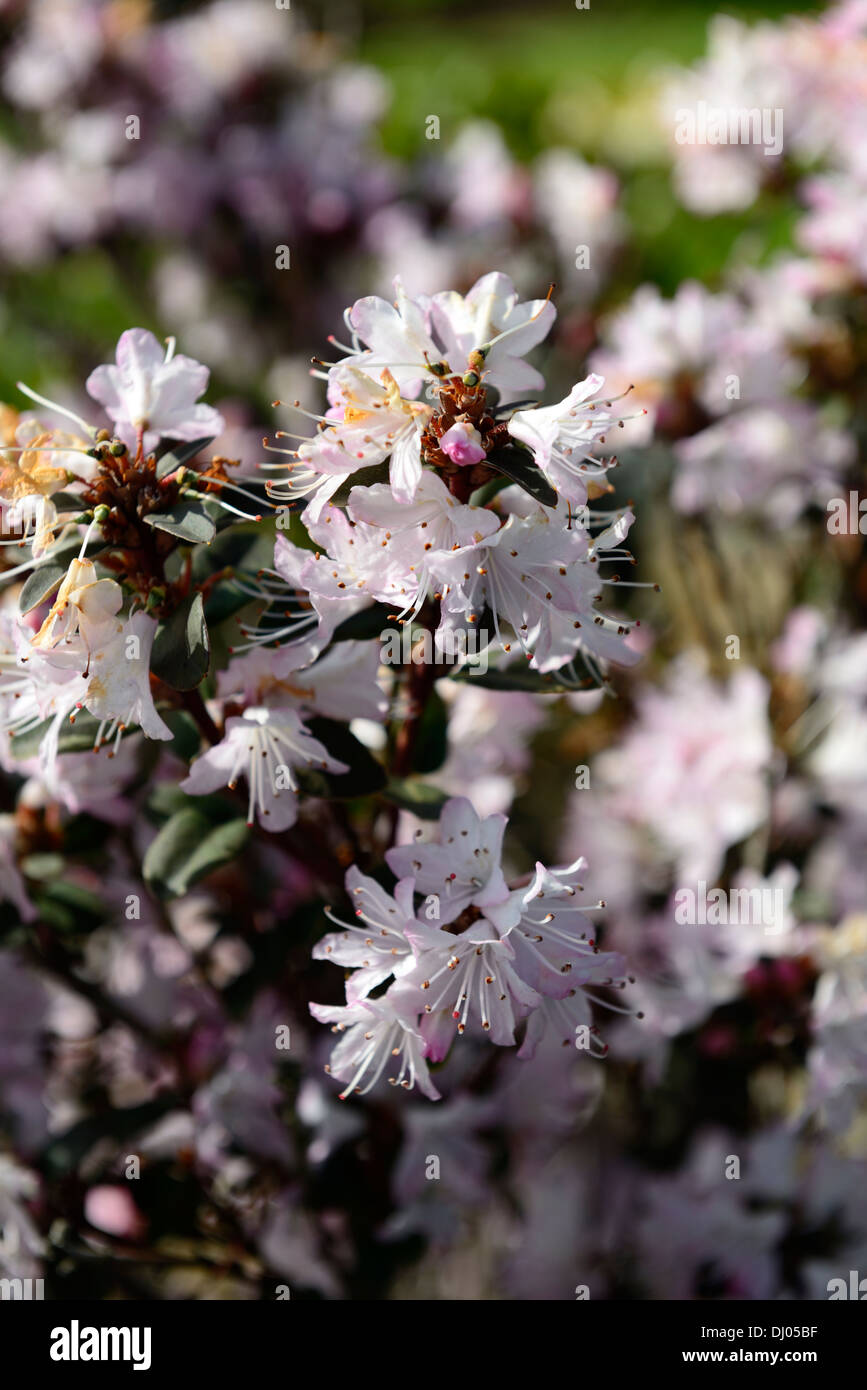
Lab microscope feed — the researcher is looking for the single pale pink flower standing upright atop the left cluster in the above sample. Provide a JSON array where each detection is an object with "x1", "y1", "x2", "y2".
[{"x1": 88, "y1": 328, "x2": 224, "y2": 450}]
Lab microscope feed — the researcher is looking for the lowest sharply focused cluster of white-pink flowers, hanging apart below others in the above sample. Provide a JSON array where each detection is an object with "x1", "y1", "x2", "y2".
[{"x1": 310, "y1": 796, "x2": 627, "y2": 1099}]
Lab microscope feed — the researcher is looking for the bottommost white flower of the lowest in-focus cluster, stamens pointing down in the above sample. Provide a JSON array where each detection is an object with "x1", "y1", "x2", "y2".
[{"x1": 310, "y1": 984, "x2": 439, "y2": 1101}]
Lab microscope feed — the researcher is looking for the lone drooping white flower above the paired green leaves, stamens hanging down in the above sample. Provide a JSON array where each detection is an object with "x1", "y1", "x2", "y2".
[{"x1": 181, "y1": 708, "x2": 349, "y2": 831}]
